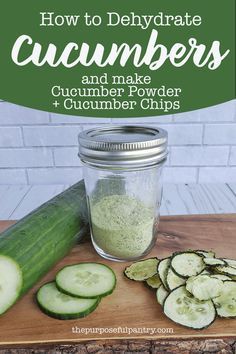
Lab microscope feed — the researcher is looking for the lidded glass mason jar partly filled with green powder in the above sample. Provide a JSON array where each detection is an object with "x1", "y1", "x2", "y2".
[{"x1": 79, "y1": 125, "x2": 167, "y2": 261}]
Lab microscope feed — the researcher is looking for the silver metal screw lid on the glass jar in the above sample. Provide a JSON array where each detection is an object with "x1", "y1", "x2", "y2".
[{"x1": 79, "y1": 125, "x2": 168, "y2": 169}]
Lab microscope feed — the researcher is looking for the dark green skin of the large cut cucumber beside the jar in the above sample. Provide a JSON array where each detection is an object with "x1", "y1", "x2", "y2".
[{"x1": 0, "y1": 181, "x2": 88, "y2": 298}]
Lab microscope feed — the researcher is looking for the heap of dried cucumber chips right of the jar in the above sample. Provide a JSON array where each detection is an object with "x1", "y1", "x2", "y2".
[{"x1": 123, "y1": 250, "x2": 236, "y2": 329}]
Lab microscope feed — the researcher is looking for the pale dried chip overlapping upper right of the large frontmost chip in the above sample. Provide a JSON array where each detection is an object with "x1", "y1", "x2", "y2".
[{"x1": 186, "y1": 274, "x2": 224, "y2": 300}]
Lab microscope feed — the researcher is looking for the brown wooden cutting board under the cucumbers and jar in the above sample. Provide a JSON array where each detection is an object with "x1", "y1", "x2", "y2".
[{"x1": 0, "y1": 214, "x2": 236, "y2": 345}]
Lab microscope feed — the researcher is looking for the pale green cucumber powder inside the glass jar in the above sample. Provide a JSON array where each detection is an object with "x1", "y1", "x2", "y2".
[{"x1": 91, "y1": 195, "x2": 155, "y2": 258}]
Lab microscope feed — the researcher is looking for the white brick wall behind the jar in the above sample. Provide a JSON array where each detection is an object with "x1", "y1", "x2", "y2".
[{"x1": 0, "y1": 100, "x2": 236, "y2": 184}]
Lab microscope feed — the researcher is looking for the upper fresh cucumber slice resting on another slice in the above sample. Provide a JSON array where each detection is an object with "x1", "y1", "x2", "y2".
[{"x1": 56, "y1": 263, "x2": 116, "y2": 298}]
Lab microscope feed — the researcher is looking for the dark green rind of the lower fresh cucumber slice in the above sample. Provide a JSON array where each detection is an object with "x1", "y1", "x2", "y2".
[{"x1": 35, "y1": 282, "x2": 101, "y2": 320}]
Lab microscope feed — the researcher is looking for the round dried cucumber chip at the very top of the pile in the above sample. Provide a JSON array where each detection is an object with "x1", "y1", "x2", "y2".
[{"x1": 171, "y1": 251, "x2": 206, "y2": 278}]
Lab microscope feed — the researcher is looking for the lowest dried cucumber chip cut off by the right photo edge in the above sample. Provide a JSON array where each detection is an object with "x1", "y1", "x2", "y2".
[{"x1": 213, "y1": 280, "x2": 236, "y2": 318}]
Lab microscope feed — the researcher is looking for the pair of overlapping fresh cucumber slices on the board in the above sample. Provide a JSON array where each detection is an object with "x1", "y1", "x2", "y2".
[{"x1": 36, "y1": 263, "x2": 116, "y2": 320}]
